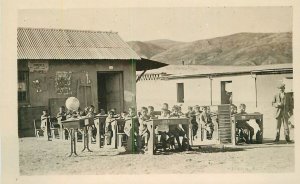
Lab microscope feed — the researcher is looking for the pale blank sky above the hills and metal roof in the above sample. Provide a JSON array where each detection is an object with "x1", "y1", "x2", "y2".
[{"x1": 18, "y1": 6, "x2": 293, "y2": 42}]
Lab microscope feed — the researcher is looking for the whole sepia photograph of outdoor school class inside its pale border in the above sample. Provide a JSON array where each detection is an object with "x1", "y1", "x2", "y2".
[{"x1": 16, "y1": 6, "x2": 295, "y2": 176}]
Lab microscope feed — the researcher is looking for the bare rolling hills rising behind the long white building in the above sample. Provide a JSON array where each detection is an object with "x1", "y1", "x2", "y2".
[{"x1": 127, "y1": 33, "x2": 292, "y2": 65}]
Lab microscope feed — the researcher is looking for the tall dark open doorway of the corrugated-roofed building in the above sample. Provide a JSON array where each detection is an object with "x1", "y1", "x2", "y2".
[{"x1": 97, "y1": 72, "x2": 124, "y2": 113}]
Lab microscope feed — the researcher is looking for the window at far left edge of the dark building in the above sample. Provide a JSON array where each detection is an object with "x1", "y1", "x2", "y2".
[{"x1": 18, "y1": 71, "x2": 28, "y2": 103}]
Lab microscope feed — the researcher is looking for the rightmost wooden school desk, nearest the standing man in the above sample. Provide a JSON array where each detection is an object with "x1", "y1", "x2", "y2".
[{"x1": 232, "y1": 113, "x2": 263, "y2": 145}]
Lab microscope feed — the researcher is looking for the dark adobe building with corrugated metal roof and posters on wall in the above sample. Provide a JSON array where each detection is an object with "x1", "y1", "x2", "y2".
[{"x1": 17, "y1": 28, "x2": 165, "y2": 137}]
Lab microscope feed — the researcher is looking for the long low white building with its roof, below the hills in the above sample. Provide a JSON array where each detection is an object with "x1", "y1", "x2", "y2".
[{"x1": 137, "y1": 64, "x2": 293, "y2": 139}]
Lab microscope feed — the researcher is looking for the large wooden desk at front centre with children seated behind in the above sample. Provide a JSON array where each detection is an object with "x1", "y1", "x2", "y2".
[{"x1": 148, "y1": 118, "x2": 190, "y2": 155}]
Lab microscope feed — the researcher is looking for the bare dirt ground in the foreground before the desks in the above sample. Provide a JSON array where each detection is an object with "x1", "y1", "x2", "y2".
[{"x1": 19, "y1": 138, "x2": 295, "y2": 175}]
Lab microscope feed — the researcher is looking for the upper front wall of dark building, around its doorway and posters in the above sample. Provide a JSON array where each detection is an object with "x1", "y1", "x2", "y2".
[{"x1": 18, "y1": 60, "x2": 136, "y2": 109}]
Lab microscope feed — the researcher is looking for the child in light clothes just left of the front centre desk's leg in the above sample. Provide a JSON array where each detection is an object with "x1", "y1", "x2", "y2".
[{"x1": 138, "y1": 107, "x2": 150, "y2": 151}]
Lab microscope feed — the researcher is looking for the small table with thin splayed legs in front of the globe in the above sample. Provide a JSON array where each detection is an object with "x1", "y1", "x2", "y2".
[{"x1": 61, "y1": 117, "x2": 94, "y2": 157}]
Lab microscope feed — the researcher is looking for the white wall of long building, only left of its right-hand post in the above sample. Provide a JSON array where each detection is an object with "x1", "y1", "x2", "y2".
[{"x1": 137, "y1": 75, "x2": 255, "y2": 110}]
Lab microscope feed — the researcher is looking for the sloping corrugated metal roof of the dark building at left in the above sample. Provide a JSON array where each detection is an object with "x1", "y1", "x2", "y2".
[{"x1": 17, "y1": 28, "x2": 141, "y2": 60}]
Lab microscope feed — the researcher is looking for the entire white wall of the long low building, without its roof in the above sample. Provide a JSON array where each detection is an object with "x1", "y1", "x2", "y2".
[{"x1": 137, "y1": 73, "x2": 293, "y2": 139}]
